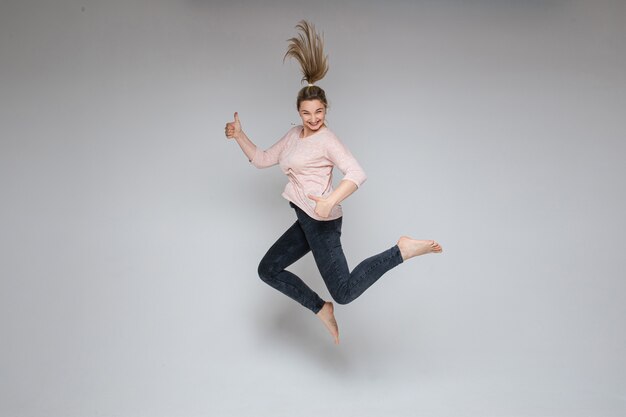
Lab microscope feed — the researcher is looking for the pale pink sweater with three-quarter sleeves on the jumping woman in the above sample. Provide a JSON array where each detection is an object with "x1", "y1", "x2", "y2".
[{"x1": 250, "y1": 125, "x2": 367, "y2": 220}]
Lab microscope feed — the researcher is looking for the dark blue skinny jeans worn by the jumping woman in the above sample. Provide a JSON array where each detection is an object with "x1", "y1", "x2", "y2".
[{"x1": 259, "y1": 202, "x2": 402, "y2": 313}]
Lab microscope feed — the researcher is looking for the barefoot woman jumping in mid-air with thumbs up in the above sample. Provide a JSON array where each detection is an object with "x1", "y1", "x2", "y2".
[{"x1": 225, "y1": 20, "x2": 442, "y2": 343}]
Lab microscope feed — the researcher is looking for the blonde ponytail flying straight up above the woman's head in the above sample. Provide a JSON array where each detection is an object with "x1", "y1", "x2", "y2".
[{"x1": 283, "y1": 20, "x2": 328, "y2": 84}]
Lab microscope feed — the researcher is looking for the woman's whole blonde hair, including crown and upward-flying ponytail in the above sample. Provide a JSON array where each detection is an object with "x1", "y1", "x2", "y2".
[{"x1": 283, "y1": 20, "x2": 328, "y2": 110}]
